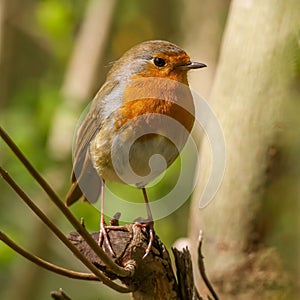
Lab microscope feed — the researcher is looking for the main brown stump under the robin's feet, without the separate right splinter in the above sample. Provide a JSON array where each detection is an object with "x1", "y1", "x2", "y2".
[{"x1": 69, "y1": 224, "x2": 180, "y2": 300}]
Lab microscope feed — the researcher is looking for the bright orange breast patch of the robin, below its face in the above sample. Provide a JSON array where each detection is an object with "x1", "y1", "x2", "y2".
[{"x1": 115, "y1": 77, "x2": 194, "y2": 132}]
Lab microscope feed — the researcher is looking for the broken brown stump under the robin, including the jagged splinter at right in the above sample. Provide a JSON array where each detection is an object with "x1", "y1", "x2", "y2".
[{"x1": 68, "y1": 224, "x2": 202, "y2": 300}]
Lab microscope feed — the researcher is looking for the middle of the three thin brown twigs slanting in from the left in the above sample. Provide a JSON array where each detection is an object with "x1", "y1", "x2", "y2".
[{"x1": 0, "y1": 166, "x2": 130, "y2": 293}]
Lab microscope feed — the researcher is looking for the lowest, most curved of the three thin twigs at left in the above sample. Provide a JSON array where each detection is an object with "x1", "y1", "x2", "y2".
[{"x1": 0, "y1": 231, "x2": 99, "y2": 281}]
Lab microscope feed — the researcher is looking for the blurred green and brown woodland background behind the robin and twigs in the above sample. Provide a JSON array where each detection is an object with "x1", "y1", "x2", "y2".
[{"x1": 0, "y1": 0, "x2": 225, "y2": 300}]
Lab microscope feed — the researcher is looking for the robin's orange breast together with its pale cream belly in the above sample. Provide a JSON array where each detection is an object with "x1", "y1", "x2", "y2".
[{"x1": 90, "y1": 78, "x2": 194, "y2": 186}]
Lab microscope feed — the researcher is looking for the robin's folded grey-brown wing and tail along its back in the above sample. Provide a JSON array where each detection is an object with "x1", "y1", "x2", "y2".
[{"x1": 66, "y1": 81, "x2": 118, "y2": 206}]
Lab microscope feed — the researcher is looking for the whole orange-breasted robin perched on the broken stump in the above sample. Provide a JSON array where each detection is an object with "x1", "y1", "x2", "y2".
[{"x1": 66, "y1": 40, "x2": 206, "y2": 256}]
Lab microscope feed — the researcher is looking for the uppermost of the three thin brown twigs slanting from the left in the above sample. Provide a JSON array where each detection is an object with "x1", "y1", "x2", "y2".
[{"x1": 0, "y1": 127, "x2": 133, "y2": 277}]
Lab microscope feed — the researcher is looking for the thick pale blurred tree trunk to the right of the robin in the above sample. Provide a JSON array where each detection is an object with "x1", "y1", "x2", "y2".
[{"x1": 190, "y1": 0, "x2": 300, "y2": 299}]
